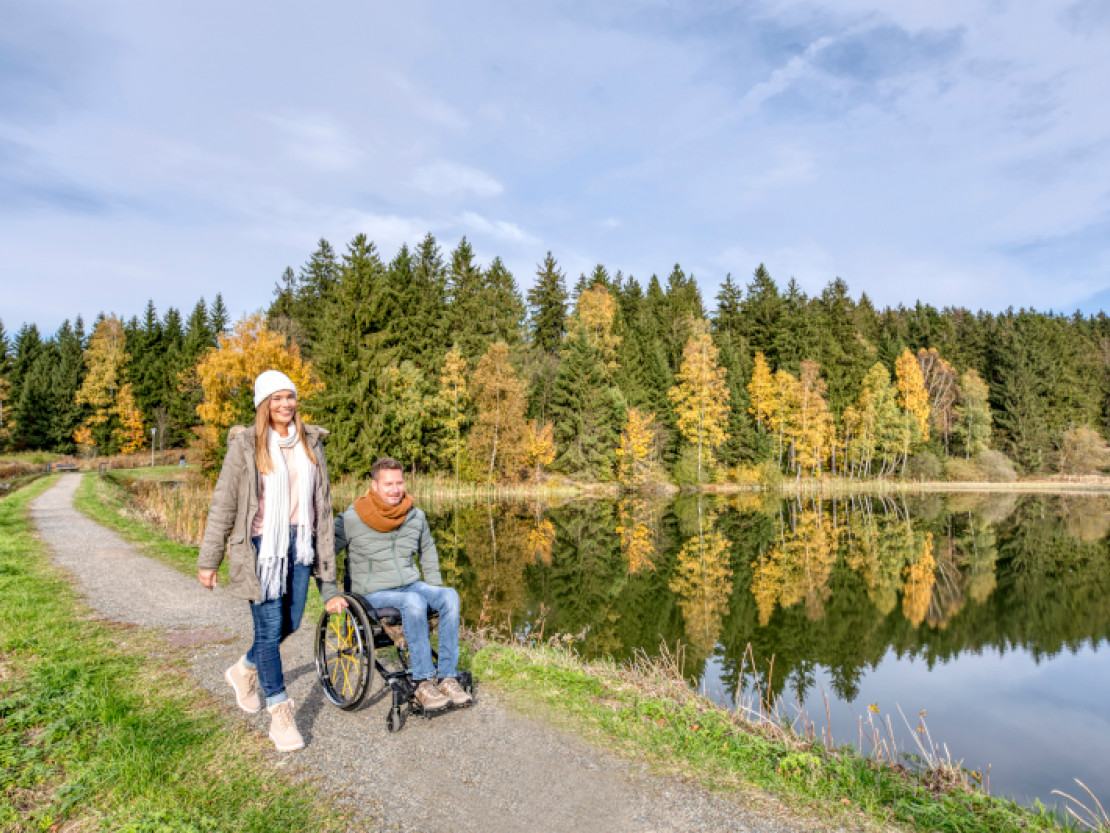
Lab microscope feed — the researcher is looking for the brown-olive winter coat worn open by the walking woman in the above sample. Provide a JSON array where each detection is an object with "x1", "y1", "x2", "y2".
[{"x1": 196, "y1": 425, "x2": 335, "y2": 602}]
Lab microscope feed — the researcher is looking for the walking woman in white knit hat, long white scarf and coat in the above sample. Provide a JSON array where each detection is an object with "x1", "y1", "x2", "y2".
[{"x1": 196, "y1": 370, "x2": 335, "y2": 752}]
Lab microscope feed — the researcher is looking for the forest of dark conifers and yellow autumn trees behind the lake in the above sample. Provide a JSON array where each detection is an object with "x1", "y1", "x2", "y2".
[{"x1": 0, "y1": 234, "x2": 1110, "y2": 488}]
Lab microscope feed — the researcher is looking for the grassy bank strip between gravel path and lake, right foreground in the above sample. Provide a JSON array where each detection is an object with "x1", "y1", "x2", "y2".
[{"x1": 473, "y1": 646, "x2": 1059, "y2": 833}]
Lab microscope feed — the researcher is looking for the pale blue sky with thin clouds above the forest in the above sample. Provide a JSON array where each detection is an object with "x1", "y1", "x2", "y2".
[{"x1": 0, "y1": 0, "x2": 1110, "y2": 334}]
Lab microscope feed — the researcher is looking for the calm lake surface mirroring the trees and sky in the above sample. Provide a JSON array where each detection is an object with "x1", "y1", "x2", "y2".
[{"x1": 427, "y1": 494, "x2": 1110, "y2": 804}]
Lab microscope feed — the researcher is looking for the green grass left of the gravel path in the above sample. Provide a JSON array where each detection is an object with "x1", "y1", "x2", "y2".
[{"x1": 0, "y1": 479, "x2": 362, "y2": 833}]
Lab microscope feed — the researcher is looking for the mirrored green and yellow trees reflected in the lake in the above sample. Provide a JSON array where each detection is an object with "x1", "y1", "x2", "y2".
[{"x1": 433, "y1": 494, "x2": 1110, "y2": 699}]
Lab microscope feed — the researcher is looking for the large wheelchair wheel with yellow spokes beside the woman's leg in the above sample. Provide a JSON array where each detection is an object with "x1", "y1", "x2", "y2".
[{"x1": 316, "y1": 595, "x2": 374, "y2": 711}]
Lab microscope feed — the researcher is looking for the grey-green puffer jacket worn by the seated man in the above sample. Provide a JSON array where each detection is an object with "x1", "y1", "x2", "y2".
[{"x1": 320, "y1": 505, "x2": 443, "y2": 602}]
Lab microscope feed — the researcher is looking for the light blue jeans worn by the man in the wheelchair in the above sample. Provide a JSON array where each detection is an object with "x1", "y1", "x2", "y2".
[{"x1": 366, "y1": 581, "x2": 458, "y2": 681}]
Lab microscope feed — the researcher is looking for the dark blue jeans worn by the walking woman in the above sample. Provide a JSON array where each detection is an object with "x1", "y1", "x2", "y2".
[{"x1": 244, "y1": 526, "x2": 312, "y2": 706}]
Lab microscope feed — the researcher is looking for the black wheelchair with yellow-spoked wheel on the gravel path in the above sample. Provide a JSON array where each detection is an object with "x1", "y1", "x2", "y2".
[{"x1": 315, "y1": 593, "x2": 474, "y2": 732}]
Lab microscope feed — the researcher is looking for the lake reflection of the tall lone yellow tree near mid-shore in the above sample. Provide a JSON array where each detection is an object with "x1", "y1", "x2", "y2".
[{"x1": 669, "y1": 508, "x2": 733, "y2": 656}]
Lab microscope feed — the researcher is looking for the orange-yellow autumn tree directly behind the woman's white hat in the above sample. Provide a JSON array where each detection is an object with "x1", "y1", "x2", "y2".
[{"x1": 193, "y1": 313, "x2": 324, "y2": 448}]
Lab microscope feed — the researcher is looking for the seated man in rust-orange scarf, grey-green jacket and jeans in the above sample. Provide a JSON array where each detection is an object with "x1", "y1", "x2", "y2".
[{"x1": 320, "y1": 458, "x2": 473, "y2": 711}]
